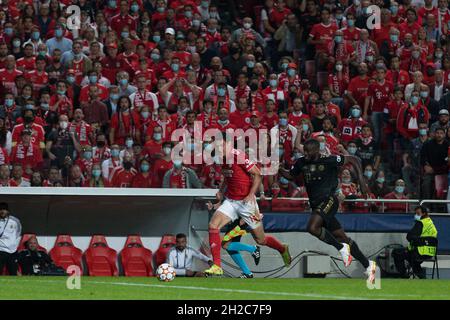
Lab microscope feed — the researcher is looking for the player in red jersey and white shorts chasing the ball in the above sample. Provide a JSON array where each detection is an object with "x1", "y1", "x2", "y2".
[{"x1": 205, "y1": 136, "x2": 292, "y2": 275}]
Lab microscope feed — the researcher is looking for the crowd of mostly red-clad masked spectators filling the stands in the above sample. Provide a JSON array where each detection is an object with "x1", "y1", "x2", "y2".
[{"x1": 0, "y1": 0, "x2": 450, "y2": 212}]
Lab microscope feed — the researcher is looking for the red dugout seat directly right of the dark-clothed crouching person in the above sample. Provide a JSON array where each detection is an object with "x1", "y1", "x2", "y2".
[{"x1": 50, "y1": 235, "x2": 83, "y2": 270}]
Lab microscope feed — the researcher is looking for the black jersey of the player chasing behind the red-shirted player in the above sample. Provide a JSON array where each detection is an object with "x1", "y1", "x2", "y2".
[{"x1": 290, "y1": 156, "x2": 344, "y2": 208}]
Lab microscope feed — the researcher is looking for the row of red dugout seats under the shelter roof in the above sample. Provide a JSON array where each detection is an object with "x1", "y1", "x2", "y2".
[{"x1": 2, "y1": 233, "x2": 175, "y2": 277}]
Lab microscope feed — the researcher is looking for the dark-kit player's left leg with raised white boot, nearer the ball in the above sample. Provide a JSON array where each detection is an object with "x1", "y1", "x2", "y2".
[{"x1": 306, "y1": 213, "x2": 352, "y2": 267}]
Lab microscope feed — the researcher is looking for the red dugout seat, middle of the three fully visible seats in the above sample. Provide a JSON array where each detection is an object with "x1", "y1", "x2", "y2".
[{"x1": 84, "y1": 235, "x2": 119, "y2": 276}]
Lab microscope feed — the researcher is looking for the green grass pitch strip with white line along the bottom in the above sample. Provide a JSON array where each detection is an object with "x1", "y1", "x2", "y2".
[{"x1": 0, "y1": 277, "x2": 450, "y2": 300}]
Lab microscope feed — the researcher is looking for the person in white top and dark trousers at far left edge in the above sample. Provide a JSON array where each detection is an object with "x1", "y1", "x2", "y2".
[{"x1": 0, "y1": 202, "x2": 22, "y2": 276}]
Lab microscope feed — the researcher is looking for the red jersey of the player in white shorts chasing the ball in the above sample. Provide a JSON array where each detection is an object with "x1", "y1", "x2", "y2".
[{"x1": 222, "y1": 149, "x2": 256, "y2": 200}]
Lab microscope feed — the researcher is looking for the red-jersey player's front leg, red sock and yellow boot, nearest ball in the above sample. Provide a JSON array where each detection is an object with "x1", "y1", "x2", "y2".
[{"x1": 205, "y1": 211, "x2": 231, "y2": 276}]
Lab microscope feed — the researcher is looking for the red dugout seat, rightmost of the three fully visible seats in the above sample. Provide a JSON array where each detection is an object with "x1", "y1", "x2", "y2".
[{"x1": 120, "y1": 235, "x2": 153, "y2": 277}]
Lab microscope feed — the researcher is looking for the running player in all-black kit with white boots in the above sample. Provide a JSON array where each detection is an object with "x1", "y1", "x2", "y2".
[{"x1": 280, "y1": 139, "x2": 376, "y2": 283}]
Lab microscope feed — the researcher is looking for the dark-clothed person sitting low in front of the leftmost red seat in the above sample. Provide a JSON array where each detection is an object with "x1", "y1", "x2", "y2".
[{"x1": 18, "y1": 236, "x2": 65, "y2": 276}]
